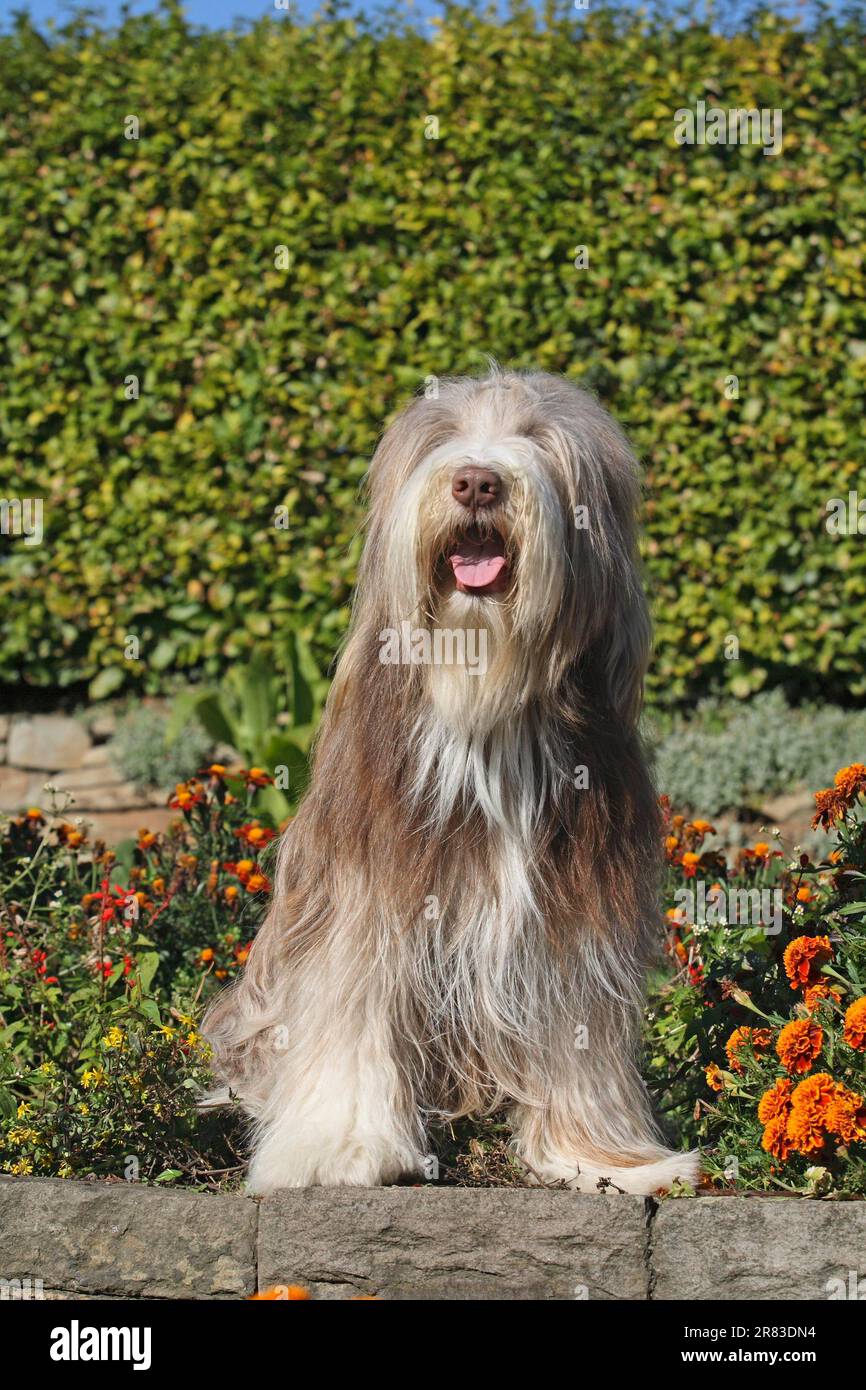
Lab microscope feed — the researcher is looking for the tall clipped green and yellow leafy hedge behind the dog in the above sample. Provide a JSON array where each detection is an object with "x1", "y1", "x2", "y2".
[{"x1": 0, "y1": 8, "x2": 866, "y2": 702}]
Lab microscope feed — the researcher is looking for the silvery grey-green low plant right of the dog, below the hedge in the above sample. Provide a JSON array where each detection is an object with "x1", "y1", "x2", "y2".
[{"x1": 646, "y1": 689, "x2": 866, "y2": 817}]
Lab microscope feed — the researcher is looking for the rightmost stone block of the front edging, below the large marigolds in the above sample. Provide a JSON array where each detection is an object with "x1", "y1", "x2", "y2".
[{"x1": 651, "y1": 1197, "x2": 866, "y2": 1302}]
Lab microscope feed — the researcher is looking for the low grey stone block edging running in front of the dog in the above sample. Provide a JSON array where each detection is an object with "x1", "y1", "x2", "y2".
[{"x1": 0, "y1": 1177, "x2": 866, "y2": 1302}]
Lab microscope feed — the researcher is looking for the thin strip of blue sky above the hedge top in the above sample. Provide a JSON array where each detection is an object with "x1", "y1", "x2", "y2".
[{"x1": 0, "y1": 0, "x2": 840, "y2": 28}]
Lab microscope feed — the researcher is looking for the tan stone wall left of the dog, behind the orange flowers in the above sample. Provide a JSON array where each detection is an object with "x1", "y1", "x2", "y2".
[{"x1": 0, "y1": 714, "x2": 174, "y2": 845}]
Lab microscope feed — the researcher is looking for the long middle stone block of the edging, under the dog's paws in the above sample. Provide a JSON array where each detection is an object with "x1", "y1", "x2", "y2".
[{"x1": 259, "y1": 1187, "x2": 648, "y2": 1301}]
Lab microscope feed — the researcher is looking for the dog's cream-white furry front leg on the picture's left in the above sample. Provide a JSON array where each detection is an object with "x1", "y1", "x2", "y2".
[{"x1": 249, "y1": 981, "x2": 424, "y2": 1193}]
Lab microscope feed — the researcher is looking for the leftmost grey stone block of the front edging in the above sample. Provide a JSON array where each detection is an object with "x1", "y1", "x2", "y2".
[{"x1": 0, "y1": 1177, "x2": 257, "y2": 1298}]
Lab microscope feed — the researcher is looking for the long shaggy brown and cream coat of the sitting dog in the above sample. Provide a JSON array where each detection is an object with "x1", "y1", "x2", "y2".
[{"x1": 206, "y1": 370, "x2": 698, "y2": 1193}]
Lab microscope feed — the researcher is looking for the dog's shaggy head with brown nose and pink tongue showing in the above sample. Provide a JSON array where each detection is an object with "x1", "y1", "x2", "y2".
[{"x1": 354, "y1": 373, "x2": 648, "y2": 720}]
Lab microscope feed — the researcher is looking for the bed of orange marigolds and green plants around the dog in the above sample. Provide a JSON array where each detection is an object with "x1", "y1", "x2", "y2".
[{"x1": 0, "y1": 763, "x2": 866, "y2": 1197}]
